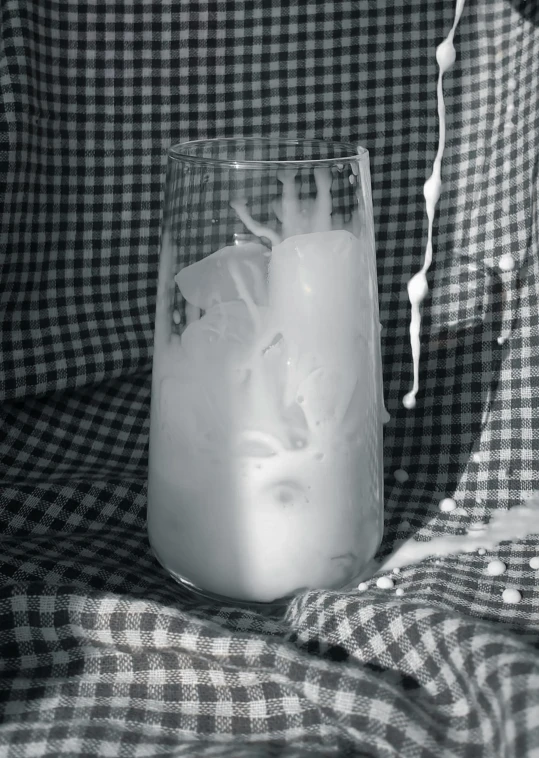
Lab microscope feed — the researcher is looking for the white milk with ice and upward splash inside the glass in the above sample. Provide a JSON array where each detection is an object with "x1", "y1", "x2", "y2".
[{"x1": 148, "y1": 169, "x2": 383, "y2": 602}]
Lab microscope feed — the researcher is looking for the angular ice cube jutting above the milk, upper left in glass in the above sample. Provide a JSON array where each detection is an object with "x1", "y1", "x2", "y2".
[{"x1": 174, "y1": 242, "x2": 269, "y2": 311}]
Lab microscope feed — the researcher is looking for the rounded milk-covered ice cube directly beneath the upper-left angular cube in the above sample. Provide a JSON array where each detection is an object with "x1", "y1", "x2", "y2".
[{"x1": 181, "y1": 300, "x2": 266, "y2": 371}]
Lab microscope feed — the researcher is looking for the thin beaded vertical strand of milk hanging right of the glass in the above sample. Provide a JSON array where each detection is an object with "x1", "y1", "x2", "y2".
[{"x1": 402, "y1": 0, "x2": 464, "y2": 409}]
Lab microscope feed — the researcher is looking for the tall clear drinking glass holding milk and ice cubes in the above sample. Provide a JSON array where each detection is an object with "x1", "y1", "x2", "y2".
[{"x1": 148, "y1": 139, "x2": 384, "y2": 603}]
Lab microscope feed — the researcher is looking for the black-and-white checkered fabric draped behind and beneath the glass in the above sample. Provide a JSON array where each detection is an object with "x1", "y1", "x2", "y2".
[{"x1": 0, "y1": 0, "x2": 539, "y2": 758}]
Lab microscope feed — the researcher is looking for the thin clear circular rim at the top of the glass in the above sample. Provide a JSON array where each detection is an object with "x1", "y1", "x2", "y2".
[{"x1": 167, "y1": 137, "x2": 369, "y2": 169}]
